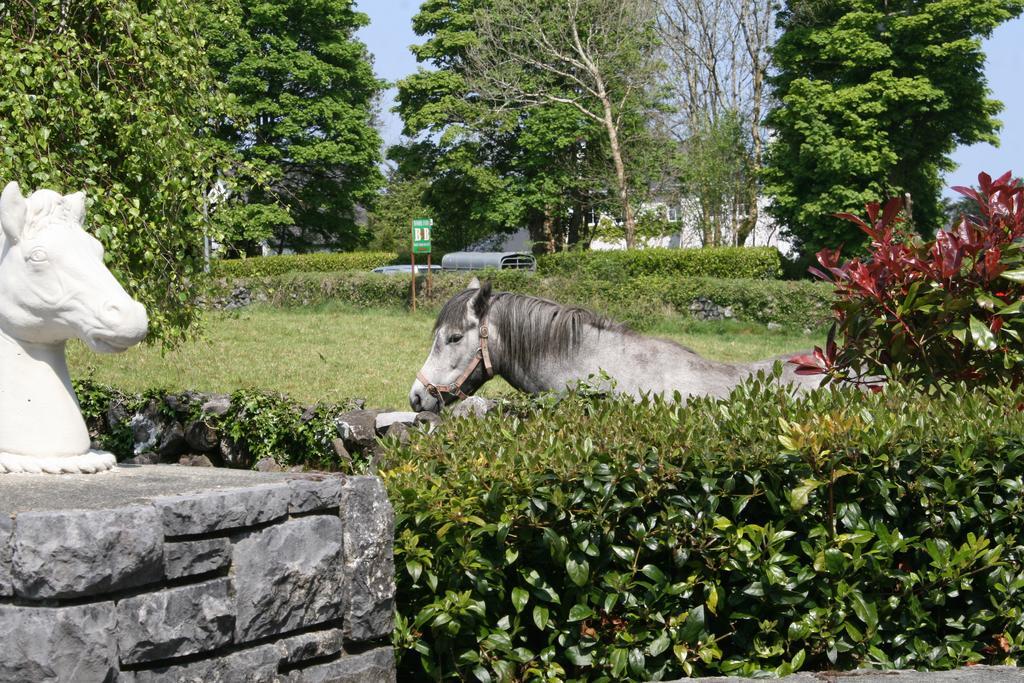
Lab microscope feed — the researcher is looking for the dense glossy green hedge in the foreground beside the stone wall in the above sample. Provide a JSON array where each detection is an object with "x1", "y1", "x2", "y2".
[{"x1": 384, "y1": 383, "x2": 1024, "y2": 681}]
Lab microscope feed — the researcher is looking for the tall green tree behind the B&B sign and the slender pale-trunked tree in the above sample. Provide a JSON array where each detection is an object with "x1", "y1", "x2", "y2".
[{"x1": 389, "y1": 0, "x2": 635, "y2": 250}]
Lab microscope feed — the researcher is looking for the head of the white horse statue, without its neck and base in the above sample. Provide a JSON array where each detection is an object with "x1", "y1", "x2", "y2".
[{"x1": 0, "y1": 182, "x2": 148, "y2": 352}]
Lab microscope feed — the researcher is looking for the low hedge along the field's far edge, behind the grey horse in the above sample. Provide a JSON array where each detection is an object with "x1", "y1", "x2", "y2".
[{"x1": 209, "y1": 270, "x2": 833, "y2": 329}]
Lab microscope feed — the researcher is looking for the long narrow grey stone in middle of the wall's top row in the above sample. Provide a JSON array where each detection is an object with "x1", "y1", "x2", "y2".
[{"x1": 153, "y1": 482, "x2": 292, "y2": 536}]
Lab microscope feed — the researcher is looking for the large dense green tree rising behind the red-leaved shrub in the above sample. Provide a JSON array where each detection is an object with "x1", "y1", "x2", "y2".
[{"x1": 766, "y1": 0, "x2": 1024, "y2": 254}]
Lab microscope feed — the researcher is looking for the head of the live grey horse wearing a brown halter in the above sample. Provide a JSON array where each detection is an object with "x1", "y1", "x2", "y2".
[{"x1": 409, "y1": 278, "x2": 492, "y2": 412}]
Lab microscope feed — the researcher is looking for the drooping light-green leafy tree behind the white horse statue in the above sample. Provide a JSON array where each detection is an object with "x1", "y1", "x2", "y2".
[{"x1": 0, "y1": 0, "x2": 237, "y2": 343}]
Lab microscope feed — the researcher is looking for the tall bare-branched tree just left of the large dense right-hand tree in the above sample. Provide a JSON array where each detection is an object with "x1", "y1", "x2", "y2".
[{"x1": 658, "y1": 0, "x2": 775, "y2": 245}]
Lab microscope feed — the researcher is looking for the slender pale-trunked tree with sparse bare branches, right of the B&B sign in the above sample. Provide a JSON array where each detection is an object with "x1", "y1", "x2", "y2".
[{"x1": 469, "y1": 0, "x2": 660, "y2": 248}]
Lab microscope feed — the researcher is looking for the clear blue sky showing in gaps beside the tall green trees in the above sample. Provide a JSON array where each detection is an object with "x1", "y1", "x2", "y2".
[{"x1": 357, "y1": 0, "x2": 1024, "y2": 194}]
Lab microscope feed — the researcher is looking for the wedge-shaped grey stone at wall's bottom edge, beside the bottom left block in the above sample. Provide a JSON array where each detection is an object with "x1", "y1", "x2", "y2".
[{"x1": 126, "y1": 645, "x2": 283, "y2": 683}]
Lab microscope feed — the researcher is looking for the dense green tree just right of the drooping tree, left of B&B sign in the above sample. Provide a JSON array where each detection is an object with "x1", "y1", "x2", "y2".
[{"x1": 208, "y1": 0, "x2": 383, "y2": 251}]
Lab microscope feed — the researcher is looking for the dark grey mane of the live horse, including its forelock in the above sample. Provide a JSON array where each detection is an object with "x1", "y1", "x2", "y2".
[{"x1": 434, "y1": 290, "x2": 636, "y2": 371}]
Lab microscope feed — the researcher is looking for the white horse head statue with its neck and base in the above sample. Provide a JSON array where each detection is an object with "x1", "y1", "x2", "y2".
[{"x1": 0, "y1": 182, "x2": 148, "y2": 473}]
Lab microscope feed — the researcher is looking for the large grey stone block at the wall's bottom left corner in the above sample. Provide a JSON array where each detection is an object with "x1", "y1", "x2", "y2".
[{"x1": 0, "y1": 602, "x2": 118, "y2": 683}]
